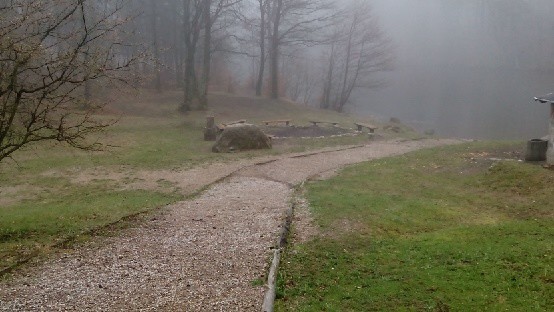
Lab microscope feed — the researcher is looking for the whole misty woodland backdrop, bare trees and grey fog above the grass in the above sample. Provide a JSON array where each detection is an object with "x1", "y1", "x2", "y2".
[{"x1": 0, "y1": 0, "x2": 554, "y2": 160}]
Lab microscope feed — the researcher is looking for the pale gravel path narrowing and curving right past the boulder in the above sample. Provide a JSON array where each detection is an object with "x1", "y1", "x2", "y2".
[{"x1": 0, "y1": 140, "x2": 460, "y2": 311}]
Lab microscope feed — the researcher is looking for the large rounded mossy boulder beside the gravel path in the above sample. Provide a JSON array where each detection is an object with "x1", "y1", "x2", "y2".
[{"x1": 212, "y1": 124, "x2": 271, "y2": 153}]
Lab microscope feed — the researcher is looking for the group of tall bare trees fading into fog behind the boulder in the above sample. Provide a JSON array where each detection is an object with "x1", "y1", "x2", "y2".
[{"x1": 125, "y1": 0, "x2": 392, "y2": 111}]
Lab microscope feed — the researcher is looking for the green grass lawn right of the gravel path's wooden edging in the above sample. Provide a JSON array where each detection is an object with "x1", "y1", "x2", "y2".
[{"x1": 277, "y1": 143, "x2": 554, "y2": 311}]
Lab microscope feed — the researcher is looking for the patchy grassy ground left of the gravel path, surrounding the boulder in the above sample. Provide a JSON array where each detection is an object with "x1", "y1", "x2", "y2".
[{"x1": 0, "y1": 92, "x2": 396, "y2": 270}]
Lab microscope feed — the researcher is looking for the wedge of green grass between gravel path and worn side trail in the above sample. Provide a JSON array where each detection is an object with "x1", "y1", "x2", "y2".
[{"x1": 0, "y1": 187, "x2": 182, "y2": 267}]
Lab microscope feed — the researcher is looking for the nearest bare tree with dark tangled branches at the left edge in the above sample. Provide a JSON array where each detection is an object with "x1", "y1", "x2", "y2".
[{"x1": 0, "y1": 0, "x2": 133, "y2": 161}]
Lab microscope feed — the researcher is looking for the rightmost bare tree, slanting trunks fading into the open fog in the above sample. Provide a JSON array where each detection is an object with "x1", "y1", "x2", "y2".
[{"x1": 320, "y1": 0, "x2": 393, "y2": 112}]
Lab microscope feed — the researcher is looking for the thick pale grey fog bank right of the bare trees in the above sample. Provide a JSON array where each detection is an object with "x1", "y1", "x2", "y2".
[{"x1": 352, "y1": 0, "x2": 554, "y2": 139}]
